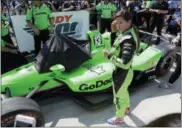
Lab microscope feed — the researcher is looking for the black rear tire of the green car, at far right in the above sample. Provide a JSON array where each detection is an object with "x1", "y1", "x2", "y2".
[{"x1": 155, "y1": 51, "x2": 175, "y2": 77}]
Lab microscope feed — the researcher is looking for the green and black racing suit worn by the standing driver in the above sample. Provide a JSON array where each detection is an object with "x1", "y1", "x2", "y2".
[{"x1": 108, "y1": 26, "x2": 140, "y2": 118}]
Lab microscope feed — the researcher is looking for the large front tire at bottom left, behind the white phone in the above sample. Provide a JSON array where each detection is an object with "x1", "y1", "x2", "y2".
[{"x1": 1, "y1": 97, "x2": 45, "y2": 127}]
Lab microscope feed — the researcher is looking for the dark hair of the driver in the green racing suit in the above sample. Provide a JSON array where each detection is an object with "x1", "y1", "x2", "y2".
[{"x1": 114, "y1": 9, "x2": 132, "y2": 21}]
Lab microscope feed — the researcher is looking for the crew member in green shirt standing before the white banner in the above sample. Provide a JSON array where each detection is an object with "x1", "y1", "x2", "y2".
[{"x1": 26, "y1": 0, "x2": 53, "y2": 55}]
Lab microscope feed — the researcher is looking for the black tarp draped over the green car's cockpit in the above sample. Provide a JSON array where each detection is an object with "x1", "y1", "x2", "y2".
[{"x1": 35, "y1": 34, "x2": 91, "y2": 73}]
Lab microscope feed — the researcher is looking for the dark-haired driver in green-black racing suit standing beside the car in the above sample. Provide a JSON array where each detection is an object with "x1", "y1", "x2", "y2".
[{"x1": 104, "y1": 9, "x2": 140, "y2": 125}]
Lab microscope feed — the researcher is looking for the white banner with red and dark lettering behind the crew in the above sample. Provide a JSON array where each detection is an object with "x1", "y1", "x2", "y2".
[{"x1": 11, "y1": 11, "x2": 89, "y2": 52}]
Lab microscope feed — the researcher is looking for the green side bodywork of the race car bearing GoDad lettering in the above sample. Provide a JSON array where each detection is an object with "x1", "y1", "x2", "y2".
[{"x1": 58, "y1": 51, "x2": 116, "y2": 92}]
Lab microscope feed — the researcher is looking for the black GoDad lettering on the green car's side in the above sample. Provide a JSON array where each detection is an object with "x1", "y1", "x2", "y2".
[{"x1": 79, "y1": 78, "x2": 112, "y2": 91}]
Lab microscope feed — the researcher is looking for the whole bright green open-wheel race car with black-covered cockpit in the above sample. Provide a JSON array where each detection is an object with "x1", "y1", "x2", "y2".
[{"x1": 1, "y1": 27, "x2": 178, "y2": 127}]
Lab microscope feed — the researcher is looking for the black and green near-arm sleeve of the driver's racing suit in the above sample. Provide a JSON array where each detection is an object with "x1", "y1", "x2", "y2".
[{"x1": 108, "y1": 39, "x2": 136, "y2": 69}]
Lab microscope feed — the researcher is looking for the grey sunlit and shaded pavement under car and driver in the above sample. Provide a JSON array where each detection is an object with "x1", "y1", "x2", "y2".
[{"x1": 39, "y1": 68, "x2": 181, "y2": 127}]
